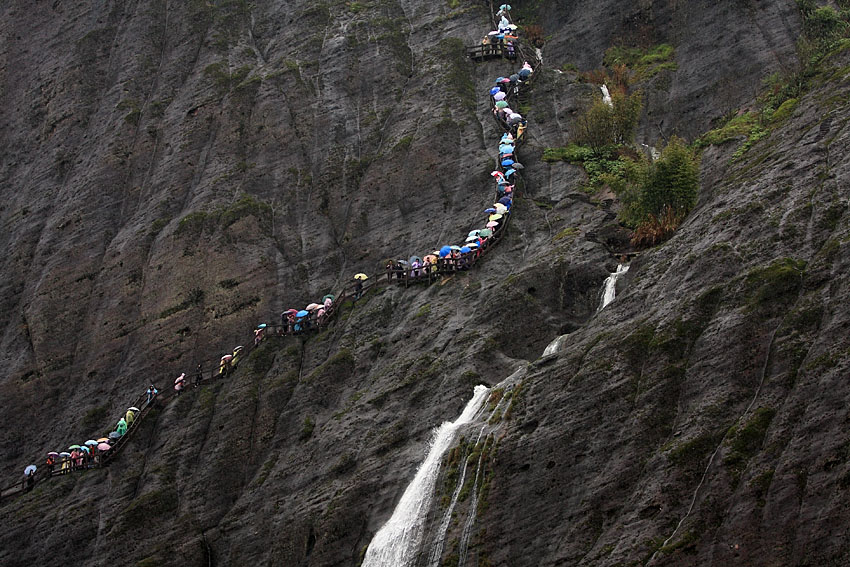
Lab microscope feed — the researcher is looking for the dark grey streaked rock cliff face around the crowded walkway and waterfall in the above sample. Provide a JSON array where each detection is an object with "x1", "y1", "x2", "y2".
[{"x1": 6, "y1": 1, "x2": 848, "y2": 565}]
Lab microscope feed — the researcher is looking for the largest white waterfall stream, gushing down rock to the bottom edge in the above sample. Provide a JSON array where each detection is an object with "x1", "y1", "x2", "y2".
[{"x1": 362, "y1": 385, "x2": 490, "y2": 567}]
